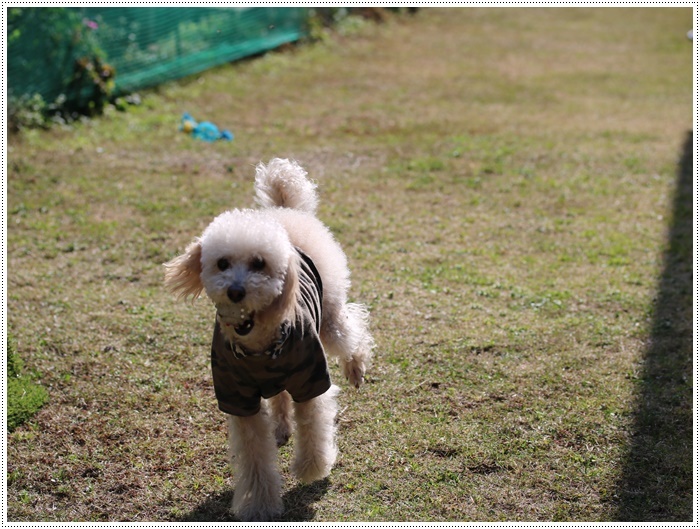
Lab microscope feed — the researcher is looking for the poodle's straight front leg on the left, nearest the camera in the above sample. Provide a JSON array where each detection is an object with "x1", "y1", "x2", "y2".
[{"x1": 228, "y1": 409, "x2": 284, "y2": 522}]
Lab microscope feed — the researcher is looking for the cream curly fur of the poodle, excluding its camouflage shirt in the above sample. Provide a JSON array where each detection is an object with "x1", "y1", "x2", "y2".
[{"x1": 165, "y1": 159, "x2": 374, "y2": 521}]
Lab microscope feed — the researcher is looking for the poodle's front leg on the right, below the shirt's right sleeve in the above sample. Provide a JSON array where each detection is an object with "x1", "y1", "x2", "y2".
[{"x1": 292, "y1": 386, "x2": 340, "y2": 483}]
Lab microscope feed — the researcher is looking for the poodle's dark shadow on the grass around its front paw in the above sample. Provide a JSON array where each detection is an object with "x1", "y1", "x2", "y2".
[{"x1": 177, "y1": 478, "x2": 330, "y2": 522}]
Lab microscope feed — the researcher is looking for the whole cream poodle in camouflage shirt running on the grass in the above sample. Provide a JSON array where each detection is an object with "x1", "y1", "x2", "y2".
[{"x1": 165, "y1": 158, "x2": 374, "y2": 521}]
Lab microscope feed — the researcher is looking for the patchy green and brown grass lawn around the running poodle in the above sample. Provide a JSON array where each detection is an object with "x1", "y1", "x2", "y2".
[{"x1": 7, "y1": 8, "x2": 693, "y2": 522}]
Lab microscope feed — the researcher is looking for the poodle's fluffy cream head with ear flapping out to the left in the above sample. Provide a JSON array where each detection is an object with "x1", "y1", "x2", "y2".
[{"x1": 166, "y1": 210, "x2": 294, "y2": 336}]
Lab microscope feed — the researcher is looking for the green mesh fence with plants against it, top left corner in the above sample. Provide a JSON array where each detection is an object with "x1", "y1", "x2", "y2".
[{"x1": 6, "y1": 7, "x2": 309, "y2": 106}]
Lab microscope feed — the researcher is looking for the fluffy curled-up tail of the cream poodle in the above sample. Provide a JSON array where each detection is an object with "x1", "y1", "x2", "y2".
[{"x1": 255, "y1": 158, "x2": 318, "y2": 213}]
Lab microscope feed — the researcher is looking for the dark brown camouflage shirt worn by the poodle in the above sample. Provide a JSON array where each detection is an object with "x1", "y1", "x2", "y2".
[{"x1": 211, "y1": 249, "x2": 331, "y2": 417}]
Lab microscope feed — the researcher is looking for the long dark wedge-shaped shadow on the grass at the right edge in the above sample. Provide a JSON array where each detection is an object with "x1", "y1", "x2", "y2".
[{"x1": 616, "y1": 132, "x2": 693, "y2": 522}]
